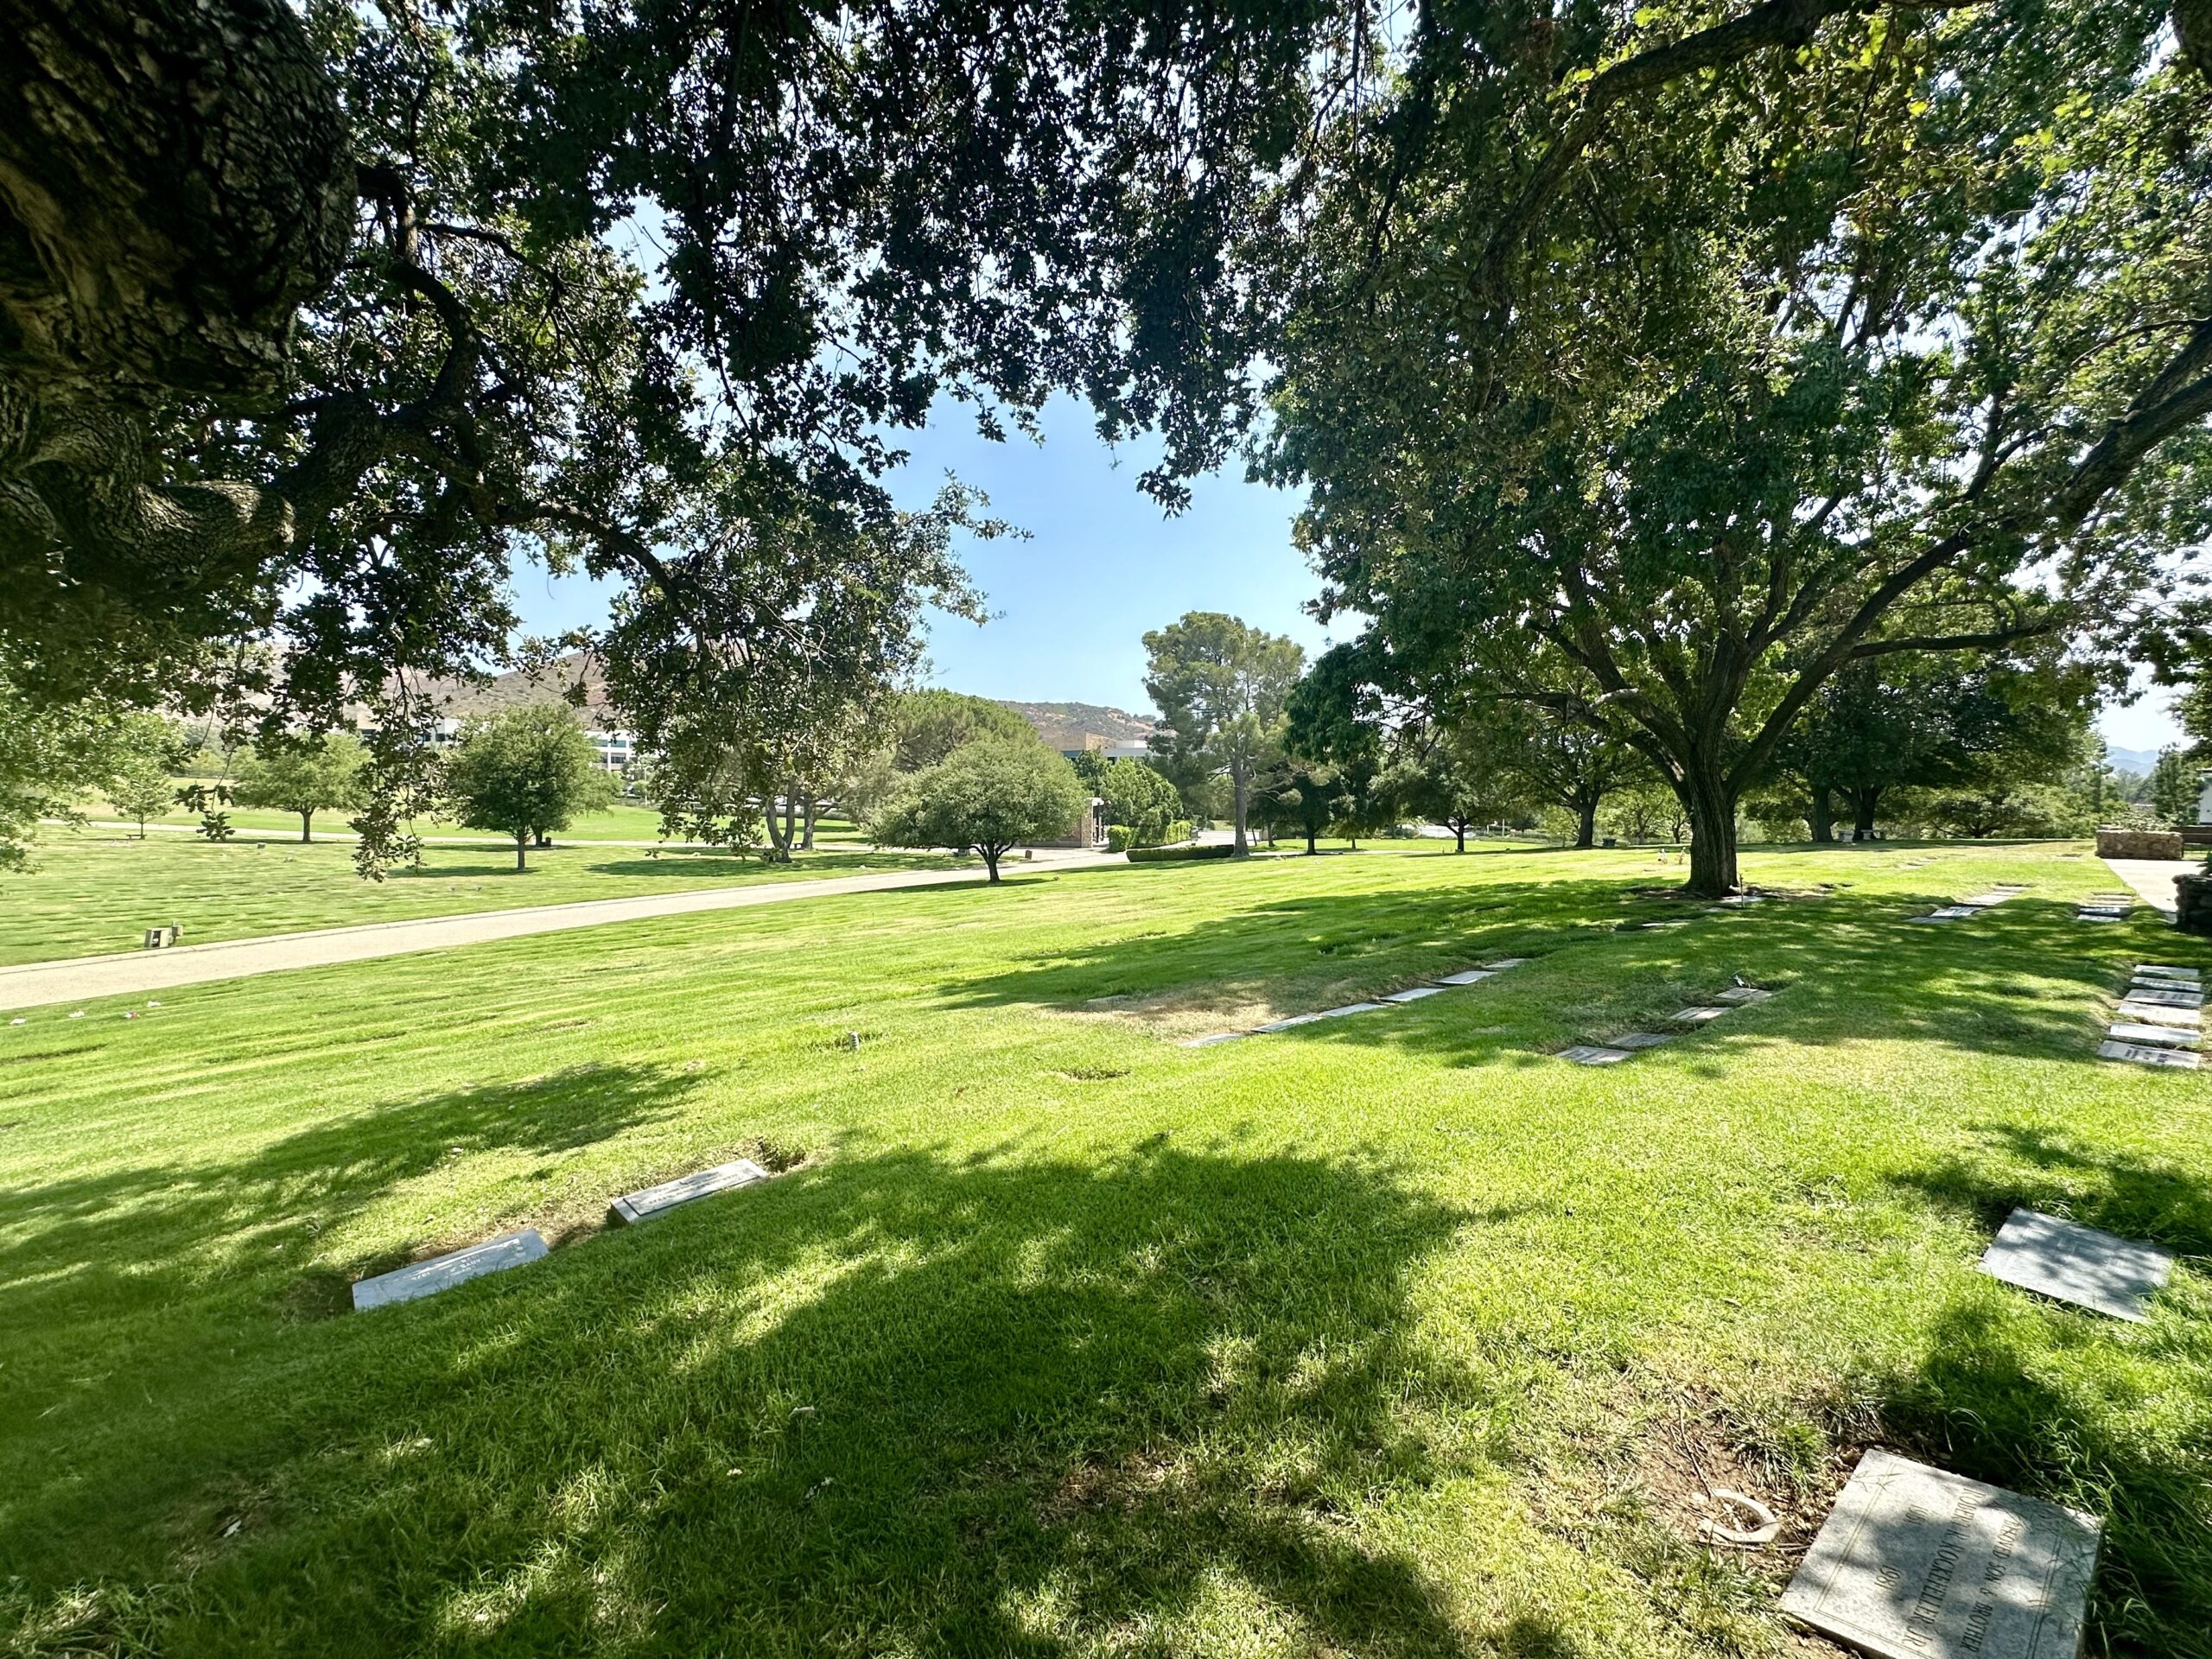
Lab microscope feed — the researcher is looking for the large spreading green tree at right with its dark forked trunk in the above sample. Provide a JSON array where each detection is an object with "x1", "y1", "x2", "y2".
[{"x1": 1263, "y1": 0, "x2": 2212, "y2": 893}]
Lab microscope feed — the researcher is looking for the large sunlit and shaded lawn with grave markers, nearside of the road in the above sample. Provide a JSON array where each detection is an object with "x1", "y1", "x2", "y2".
[{"x1": 0, "y1": 847, "x2": 2212, "y2": 1659}]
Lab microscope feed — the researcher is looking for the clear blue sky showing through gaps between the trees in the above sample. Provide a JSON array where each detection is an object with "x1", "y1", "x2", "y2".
[{"x1": 502, "y1": 398, "x2": 2177, "y2": 750}]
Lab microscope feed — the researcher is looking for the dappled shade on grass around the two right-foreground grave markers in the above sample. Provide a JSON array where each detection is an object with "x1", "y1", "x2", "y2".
[{"x1": 1876, "y1": 1123, "x2": 2212, "y2": 1659}]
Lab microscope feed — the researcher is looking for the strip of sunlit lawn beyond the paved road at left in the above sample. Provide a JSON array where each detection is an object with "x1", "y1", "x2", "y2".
[{"x1": 0, "y1": 827, "x2": 976, "y2": 964}]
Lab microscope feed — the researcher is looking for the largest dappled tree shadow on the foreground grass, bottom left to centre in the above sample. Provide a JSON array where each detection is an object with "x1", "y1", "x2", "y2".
[{"x1": 0, "y1": 1144, "x2": 1597, "y2": 1659}]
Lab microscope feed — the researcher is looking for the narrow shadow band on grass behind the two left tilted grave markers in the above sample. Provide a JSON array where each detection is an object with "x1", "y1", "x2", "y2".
[{"x1": 0, "y1": 1064, "x2": 696, "y2": 1330}]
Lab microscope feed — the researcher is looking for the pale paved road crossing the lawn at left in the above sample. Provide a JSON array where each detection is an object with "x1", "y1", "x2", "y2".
[{"x1": 0, "y1": 852, "x2": 1126, "y2": 1008}]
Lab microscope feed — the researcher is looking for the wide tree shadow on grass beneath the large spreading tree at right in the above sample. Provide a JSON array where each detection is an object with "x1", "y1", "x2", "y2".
[{"x1": 944, "y1": 878, "x2": 2172, "y2": 1064}]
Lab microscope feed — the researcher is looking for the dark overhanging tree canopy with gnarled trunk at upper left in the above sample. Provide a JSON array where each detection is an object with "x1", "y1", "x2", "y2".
[{"x1": 0, "y1": 0, "x2": 1343, "y2": 862}]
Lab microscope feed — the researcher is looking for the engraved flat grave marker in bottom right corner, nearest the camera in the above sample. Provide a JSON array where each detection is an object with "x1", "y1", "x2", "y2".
[{"x1": 1781, "y1": 1446, "x2": 2104, "y2": 1659}]
